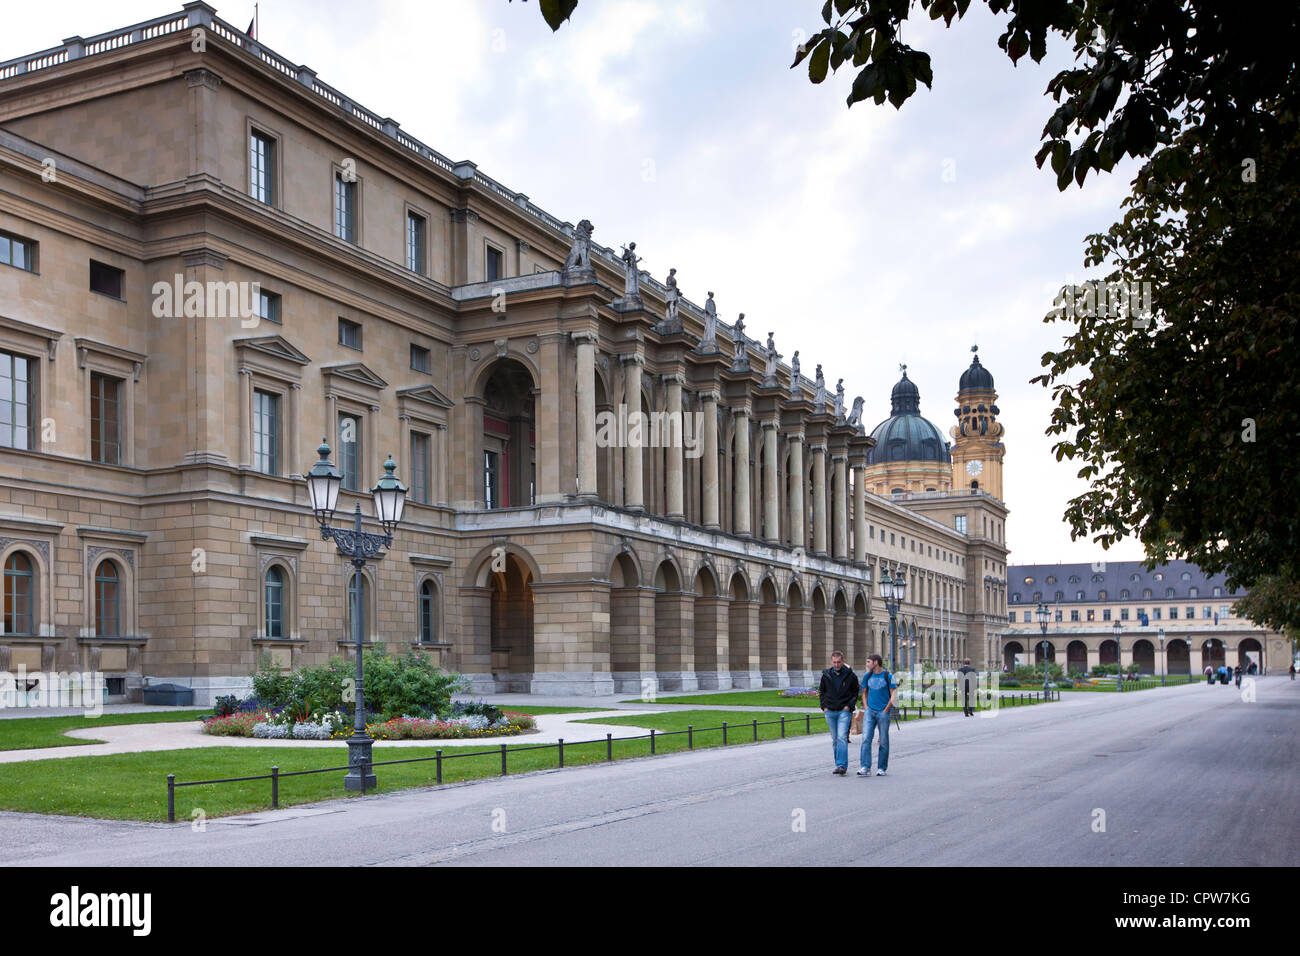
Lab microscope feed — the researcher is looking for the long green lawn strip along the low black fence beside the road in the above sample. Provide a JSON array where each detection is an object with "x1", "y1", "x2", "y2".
[{"x1": 0, "y1": 711, "x2": 826, "y2": 823}]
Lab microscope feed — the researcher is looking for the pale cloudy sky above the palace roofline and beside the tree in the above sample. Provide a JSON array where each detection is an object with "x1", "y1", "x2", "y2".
[{"x1": 0, "y1": 0, "x2": 1140, "y2": 563}]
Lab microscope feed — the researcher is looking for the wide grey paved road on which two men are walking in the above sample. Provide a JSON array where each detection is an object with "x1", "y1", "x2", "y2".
[{"x1": 0, "y1": 678, "x2": 1300, "y2": 866}]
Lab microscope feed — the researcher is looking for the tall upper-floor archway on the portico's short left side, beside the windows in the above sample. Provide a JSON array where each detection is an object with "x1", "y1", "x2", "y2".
[{"x1": 478, "y1": 359, "x2": 537, "y2": 509}]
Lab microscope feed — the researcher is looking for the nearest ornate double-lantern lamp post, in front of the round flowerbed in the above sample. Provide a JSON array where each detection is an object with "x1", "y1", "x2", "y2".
[{"x1": 307, "y1": 438, "x2": 407, "y2": 791}]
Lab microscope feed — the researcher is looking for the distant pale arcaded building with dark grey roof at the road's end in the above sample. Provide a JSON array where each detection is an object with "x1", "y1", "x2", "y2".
[{"x1": 1000, "y1": 561, "x2": 1291, "y2": 674}]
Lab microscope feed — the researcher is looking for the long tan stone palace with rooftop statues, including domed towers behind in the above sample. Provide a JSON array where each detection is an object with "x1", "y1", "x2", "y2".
[{"x1": 0, "y1": 3, "x2": 1008, "y2": 702}]
